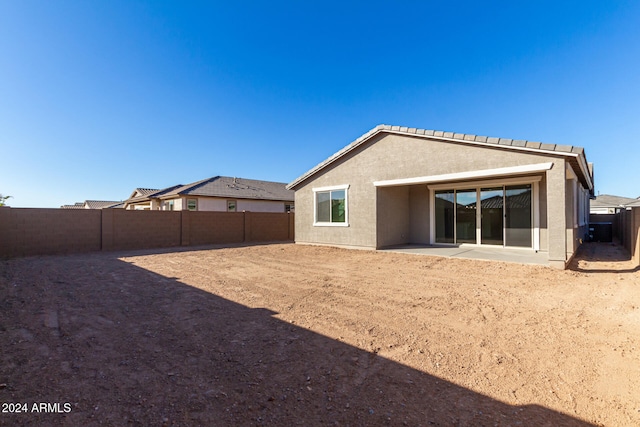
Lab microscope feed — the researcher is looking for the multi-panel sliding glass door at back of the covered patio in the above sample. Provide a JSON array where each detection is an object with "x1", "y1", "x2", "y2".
[{"x1": 434, "y1": 184, "x2": 533, "y2": 248}]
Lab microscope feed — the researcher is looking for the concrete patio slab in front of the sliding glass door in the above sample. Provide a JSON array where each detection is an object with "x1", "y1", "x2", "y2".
[{"x1": 379, "y1": 245, "x2": 549, "y2": 266}]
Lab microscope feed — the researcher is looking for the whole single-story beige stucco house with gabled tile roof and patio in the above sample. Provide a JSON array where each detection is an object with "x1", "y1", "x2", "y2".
[{"x1": 287, "y1": 125, "x2": 593, "y2": 268}]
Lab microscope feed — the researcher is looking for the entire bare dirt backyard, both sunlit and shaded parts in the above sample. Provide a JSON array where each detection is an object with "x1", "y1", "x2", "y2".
[{"x1": 0, "y1": 244, "x2": 640, "y2": 426}]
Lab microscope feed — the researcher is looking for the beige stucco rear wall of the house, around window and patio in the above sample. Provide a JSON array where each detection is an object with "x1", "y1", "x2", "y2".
[{"x1": 295, "y1": 134, "x2": 584, "y2": 263}]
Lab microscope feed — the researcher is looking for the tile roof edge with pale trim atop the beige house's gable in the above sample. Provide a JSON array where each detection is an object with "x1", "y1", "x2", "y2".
[{"x1": 287, "y1": 125, "x2": 593, "y2": 188}]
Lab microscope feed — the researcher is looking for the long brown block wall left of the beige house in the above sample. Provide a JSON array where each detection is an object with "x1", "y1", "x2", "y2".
[{"x1": 0, "y1": 207, "x2": 294, "y2": 257}]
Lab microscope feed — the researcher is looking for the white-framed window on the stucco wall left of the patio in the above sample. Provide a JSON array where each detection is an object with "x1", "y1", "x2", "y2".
[{"x1": 313, "y1": 185, "x2": 349, "y2": 227}]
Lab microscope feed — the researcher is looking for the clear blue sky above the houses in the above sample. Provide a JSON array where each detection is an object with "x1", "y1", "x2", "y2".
[{"x1": 0, "y1": 0, "x2": 640, "y2": 207}]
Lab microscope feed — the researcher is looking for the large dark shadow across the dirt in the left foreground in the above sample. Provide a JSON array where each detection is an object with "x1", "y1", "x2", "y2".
[{"x1": 0, "y1": 254, "x2": 591, "y2": 426}]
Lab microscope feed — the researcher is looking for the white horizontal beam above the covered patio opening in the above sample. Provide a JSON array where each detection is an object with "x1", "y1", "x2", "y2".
[{"x1": 373, "y1": 162, "x2": 553, "y2": 187}]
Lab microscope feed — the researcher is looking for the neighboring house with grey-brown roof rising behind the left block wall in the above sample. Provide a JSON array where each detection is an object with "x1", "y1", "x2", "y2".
[{"x1": 125, "y1": 176, "x2": 294, "y2": 212}]
